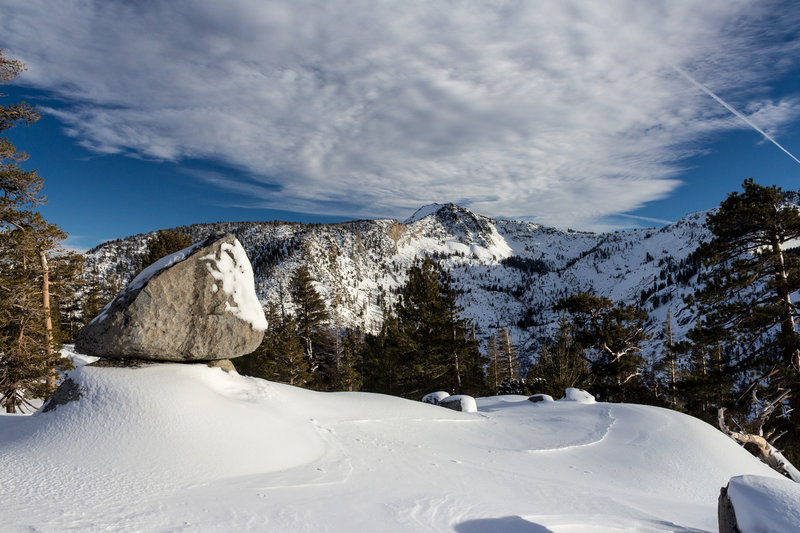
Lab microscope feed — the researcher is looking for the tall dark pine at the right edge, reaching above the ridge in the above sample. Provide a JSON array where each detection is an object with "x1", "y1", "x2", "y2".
[{"x1": 687, "y1": 178, "x2": 800, "y2": 454}]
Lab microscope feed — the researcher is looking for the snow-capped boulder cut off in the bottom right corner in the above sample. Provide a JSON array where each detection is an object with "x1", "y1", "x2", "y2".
[{"x1": 720, "y1": 475, "x2": 800, "y2": 533}]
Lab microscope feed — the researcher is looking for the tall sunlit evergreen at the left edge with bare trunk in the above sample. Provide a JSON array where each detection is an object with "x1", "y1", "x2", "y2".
[{"x1": 0, "y1": 51, "x2": 76, "y2": 413}]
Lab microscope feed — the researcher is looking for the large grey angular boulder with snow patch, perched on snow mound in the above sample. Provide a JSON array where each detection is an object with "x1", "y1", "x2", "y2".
[{"x1": 75, "y1": 234, "x2": 267, "y2": 361}]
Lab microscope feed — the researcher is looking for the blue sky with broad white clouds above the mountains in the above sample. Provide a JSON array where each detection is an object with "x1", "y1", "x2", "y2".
[{"x1": 0, "y1": 0, "x2": 800, "y2": 248}]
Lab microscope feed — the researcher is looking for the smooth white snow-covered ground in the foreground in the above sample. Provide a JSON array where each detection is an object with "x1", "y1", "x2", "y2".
[{"x1": 0, "y1": 352, "x2": 778, "y2": 533}]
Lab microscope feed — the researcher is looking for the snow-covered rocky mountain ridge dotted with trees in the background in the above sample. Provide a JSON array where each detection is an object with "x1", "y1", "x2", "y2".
[{"x1": 87, "y1": 204, "x2": 708, "y2": 353}]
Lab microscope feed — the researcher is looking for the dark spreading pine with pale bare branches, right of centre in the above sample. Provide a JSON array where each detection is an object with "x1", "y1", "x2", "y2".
[{"x1": 556, "y1": 293, "x2": 649, "y2": 401}]
